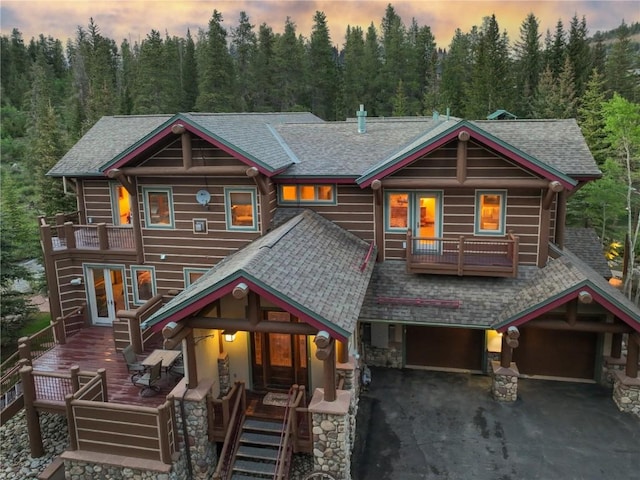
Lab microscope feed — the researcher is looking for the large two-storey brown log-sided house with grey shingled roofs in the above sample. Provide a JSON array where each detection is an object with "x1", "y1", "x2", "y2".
[{"x1": 35, "y1": 109, "x2": 640, "y2": 478}]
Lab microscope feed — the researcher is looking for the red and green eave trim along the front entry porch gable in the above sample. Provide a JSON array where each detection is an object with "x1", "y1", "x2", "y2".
[{"x1": 140, "y1": 271, "x2": 351, "y2": 342}]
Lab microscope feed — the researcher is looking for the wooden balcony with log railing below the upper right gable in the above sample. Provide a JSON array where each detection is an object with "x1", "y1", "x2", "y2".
[{"x1": 407, "y1": 232, "x2": 518, "y2": 277}]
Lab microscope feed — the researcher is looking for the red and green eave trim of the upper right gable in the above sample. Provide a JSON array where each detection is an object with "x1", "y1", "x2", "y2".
[{"x1": 356, "y1": 120, "x2": 578, "y2": 190}]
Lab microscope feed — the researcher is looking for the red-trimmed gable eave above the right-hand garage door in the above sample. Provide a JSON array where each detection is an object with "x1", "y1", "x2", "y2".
[{"x1": 491, "y1": 280, "x2": 640, "y2": 333}]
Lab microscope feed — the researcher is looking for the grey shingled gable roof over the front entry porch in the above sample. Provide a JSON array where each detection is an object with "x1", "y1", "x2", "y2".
[{"x1": 144, "y1": 210, "x2": 375, "y2": 339}]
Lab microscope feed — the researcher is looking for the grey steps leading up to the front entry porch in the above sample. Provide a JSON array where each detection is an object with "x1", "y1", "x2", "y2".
[{"x1": 231, "y1": 417, "x2": 283, "y2": 480}]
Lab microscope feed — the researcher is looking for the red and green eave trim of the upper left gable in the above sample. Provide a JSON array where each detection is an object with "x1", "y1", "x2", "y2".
[{"x1": 99, "y1": 114, "x2": 294, "y2": 177}]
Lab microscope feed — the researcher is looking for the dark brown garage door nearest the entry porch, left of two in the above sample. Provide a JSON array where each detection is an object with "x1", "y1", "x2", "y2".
[{"x1": 406, "y1": 325, "x2": 485, "y2": 371}]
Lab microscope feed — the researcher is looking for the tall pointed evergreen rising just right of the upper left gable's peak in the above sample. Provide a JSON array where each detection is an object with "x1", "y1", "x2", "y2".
[{"x1": 196, "y1": 10, "x2": 237, "y2": 112}]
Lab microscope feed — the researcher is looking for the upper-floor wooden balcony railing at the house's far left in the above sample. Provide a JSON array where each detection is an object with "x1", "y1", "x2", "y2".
[{"x1": 40, "y1": 215, "x2": 136, "y2": 254}]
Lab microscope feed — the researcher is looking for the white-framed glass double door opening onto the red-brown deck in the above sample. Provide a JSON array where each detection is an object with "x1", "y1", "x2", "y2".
[{"x1": 84, "y1": 265, "x2": 126, "y2": 325}]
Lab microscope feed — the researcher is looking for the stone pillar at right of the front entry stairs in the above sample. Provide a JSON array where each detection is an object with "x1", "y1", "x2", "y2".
[{"x1": 309, "y1": 388, "x2": 354, "y2": 480}]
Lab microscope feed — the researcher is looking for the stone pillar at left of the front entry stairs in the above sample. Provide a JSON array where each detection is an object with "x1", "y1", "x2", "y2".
[{"x1": 171, "y1": 379, "x2": 218, "y2": 480}]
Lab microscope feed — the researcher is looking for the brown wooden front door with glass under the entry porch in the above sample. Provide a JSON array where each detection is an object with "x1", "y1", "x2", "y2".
[{"x1": 251, "y1": 312, "x2": 308, "y2": 390}]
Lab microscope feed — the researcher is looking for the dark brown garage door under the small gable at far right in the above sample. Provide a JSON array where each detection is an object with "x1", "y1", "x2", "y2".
[{"x1": 513, "y1": 328, "x2": 598, "y2": 380}]
